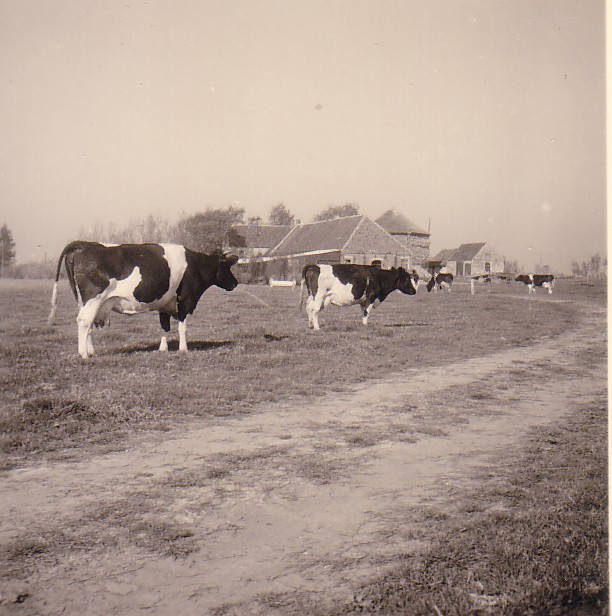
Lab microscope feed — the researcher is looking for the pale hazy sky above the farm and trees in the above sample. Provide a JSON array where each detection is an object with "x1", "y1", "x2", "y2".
[{"x1": 0, "y1": 0, "x2": 606, "y2": 271}]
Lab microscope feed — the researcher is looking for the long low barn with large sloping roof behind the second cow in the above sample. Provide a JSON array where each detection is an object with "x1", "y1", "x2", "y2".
[{"x1": 227, "y1": 215, "x2": 413, "y2": 281}]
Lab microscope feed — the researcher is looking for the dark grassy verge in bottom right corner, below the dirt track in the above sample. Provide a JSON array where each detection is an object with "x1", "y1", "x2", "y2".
[{"x1": 340, "y1": 398, "x2": 609, "y2": 616}]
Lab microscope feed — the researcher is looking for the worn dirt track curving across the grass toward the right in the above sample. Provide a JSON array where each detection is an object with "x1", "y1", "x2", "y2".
[{"x1": 0, "y1": 309, "x2": 607, "y2": 616}]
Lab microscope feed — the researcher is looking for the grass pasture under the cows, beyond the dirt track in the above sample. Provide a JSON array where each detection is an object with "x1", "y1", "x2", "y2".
[{"x1": 0, "y1": 280, "x2": 584, "y2": 467}]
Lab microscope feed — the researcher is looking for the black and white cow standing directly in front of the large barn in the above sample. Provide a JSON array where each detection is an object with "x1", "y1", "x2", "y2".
[{"x1": 301, "y1": 263, "x2": 416, "y2": 329}]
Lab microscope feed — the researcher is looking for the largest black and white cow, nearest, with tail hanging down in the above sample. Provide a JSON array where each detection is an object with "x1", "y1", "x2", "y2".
[{"x1": 49, "y1": 241, "x2": 238, "y2": 358}]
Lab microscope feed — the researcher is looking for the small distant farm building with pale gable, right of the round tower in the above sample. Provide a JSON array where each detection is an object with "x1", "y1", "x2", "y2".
[{"x1": 429, "y1": 242, "x2": 504, "y2": 276}]
